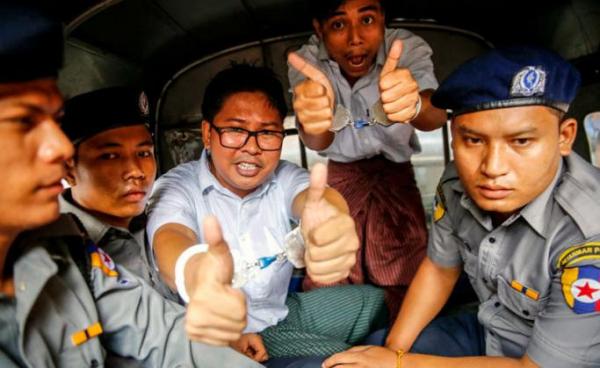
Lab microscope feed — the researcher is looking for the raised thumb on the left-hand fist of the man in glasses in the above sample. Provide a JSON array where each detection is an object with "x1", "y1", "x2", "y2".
[{"x1": 202, "y1": 216, "x2": 233, "y2": 284}]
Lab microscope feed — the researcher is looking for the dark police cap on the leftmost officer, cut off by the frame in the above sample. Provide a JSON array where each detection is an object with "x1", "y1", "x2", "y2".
[{"x1": 0, "y1": 0, "x2": 63, "y2": 83}]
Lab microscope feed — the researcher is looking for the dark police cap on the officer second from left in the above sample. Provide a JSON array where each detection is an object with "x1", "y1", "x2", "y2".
[{"x1": 61, "y1": 87, "x2": 149, "y2": 144}]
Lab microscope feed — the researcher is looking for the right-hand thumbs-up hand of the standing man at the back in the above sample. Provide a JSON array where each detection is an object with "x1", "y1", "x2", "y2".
[{"x1": 379, "y1": 40, "x2": 420, "y2": 123}]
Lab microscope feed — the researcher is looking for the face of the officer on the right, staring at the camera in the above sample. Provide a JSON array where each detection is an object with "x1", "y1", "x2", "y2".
[{"x1": 452, "y1": 106, "x2": 577, "y2": 220}]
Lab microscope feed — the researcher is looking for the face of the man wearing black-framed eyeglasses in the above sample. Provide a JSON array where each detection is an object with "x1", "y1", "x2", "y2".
[{"x1": 202, "y1": 92, "x2": 283, "y2": 197}]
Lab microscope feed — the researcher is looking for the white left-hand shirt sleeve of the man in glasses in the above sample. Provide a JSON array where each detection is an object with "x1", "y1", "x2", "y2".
[{"x1": 146, "y1": 170, "x2": 201, "y2": 246}]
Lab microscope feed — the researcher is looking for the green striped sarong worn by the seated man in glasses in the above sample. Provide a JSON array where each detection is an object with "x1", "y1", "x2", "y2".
[{"x1": 260, "y1": 285, "x2": 388, "y2": 358}]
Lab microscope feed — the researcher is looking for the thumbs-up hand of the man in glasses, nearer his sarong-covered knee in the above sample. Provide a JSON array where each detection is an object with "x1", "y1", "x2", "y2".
[{"x1": 301, "y1": 164, "x2": 359, "y2": 284}]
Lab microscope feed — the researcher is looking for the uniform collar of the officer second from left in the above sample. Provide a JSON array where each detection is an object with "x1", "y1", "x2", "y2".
[{"x1": 59, "y1": 189, "x2": 139, "y2": 244}]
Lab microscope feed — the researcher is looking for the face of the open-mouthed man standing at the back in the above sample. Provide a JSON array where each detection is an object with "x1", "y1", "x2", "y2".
[{"x1": 313, "y1": 0, "x2": 385, "y2": 84}]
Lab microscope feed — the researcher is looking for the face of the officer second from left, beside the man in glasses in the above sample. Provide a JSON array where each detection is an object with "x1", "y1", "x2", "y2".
[{"x1": 69, "y1": 122, "x2": 156, "y2": 228}]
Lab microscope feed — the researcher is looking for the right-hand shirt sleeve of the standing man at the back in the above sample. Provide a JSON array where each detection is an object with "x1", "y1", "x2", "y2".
[{"x1": 386, "y1": 29, "x2": 438, "y2": 91}]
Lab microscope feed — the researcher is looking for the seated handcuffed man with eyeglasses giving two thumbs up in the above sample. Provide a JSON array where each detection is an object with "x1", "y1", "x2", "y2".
[{"x1": 148, "y1": 65, "x2": 386, "y2": 366}]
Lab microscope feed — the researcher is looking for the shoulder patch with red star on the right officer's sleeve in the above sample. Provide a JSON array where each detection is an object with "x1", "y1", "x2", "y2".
[{"x1": 561, "y1": 266, "x2": 600, "y2": 314}]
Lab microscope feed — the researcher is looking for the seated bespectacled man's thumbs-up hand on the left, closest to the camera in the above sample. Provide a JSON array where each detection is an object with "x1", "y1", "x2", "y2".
[{"x1": 185, "y1": 216, "x2": 246, "y2": 346}]
